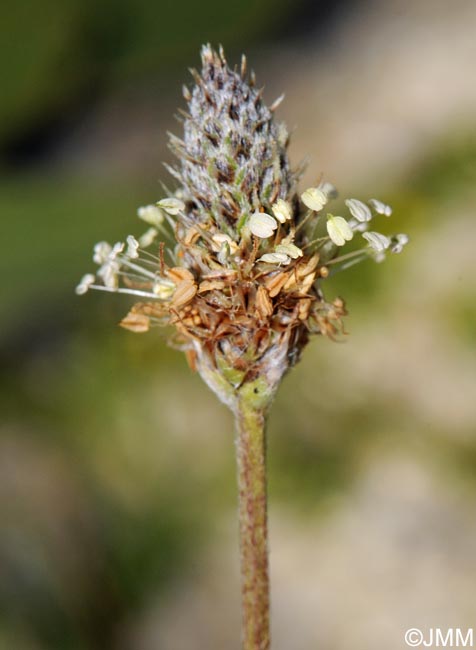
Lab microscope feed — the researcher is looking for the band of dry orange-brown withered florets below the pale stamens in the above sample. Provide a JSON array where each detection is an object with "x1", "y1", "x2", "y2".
[{"x1": 121, "y1": 250, "x2": 346, "y2": 390}]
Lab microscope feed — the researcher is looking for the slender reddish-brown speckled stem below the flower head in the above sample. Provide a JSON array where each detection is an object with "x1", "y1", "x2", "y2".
[{"x1": 235, "y1": 396, "x2": 270, "y2": 650}]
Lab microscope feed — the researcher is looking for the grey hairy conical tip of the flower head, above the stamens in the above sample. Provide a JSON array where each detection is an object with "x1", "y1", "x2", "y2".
[{"x1": 170, "y1": 45, "x2": 295, "y2": 227}]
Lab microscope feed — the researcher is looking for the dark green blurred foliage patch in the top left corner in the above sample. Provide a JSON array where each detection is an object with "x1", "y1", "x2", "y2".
[{"x1": 0, "y1": 0, "x2": 299, "y2": 153}]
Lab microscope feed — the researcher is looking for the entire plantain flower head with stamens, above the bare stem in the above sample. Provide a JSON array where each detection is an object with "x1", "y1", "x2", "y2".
[{"x1": 77, "y1": 45, "x2": 408, "y2": 408}]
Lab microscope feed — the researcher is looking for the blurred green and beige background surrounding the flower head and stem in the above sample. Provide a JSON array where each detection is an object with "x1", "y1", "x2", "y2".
[{"x1": 0, "y1": 0, "x2": 476, "y2": 650}]
